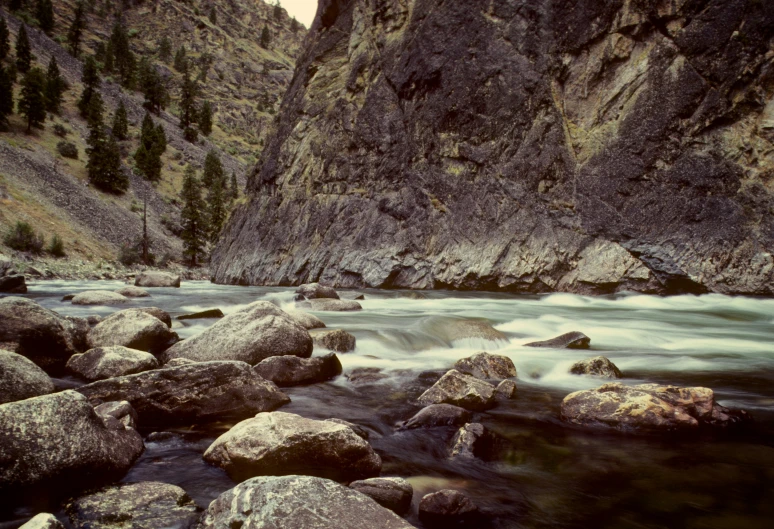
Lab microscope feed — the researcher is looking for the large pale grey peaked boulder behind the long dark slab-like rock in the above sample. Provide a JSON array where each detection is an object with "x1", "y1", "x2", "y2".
[{"x1": 165, "y1": 301, "x2": 313, "y2": 365}]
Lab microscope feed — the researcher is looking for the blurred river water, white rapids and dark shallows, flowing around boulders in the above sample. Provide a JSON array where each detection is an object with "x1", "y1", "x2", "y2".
[{"x1": 0, "y1": 281, "x2": 774, "y2": 529}]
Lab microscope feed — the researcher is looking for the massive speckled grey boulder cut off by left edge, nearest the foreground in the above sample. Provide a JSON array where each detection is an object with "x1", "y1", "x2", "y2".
[{"x1": 0, "y1": 391, "x2": 144, "y2": 490}]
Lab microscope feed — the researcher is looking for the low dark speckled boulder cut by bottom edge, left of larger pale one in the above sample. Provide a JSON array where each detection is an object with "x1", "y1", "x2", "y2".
[{"x1": 65, "y1": 481, "x2": 199, "y2": 529}]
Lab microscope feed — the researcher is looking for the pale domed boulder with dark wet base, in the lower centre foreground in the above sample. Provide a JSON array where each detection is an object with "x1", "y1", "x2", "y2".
[{"x1": 204, "y1": 411, "x2": 382, "y2": 481}]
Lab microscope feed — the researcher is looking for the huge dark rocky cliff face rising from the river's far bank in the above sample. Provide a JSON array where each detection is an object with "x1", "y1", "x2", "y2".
[{"x1": 212, "y1": 0, "x2": 774, "y2": 295}]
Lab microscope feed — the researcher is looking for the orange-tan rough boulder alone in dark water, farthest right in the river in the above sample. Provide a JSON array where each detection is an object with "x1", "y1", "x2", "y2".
[{"x1": 561, "y1": 382, "x2": 750, "y2": 431}]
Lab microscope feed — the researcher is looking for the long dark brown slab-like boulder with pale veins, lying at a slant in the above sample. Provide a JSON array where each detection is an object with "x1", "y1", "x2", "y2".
[{"x1": 78, "y1": 362, "x2": 290, "y2": 425}]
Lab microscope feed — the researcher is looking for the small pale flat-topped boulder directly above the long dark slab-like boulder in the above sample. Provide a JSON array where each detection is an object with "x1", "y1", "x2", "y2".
[{"x1": 67, "y1": 345, "x2": 159, "y2": 381}]
